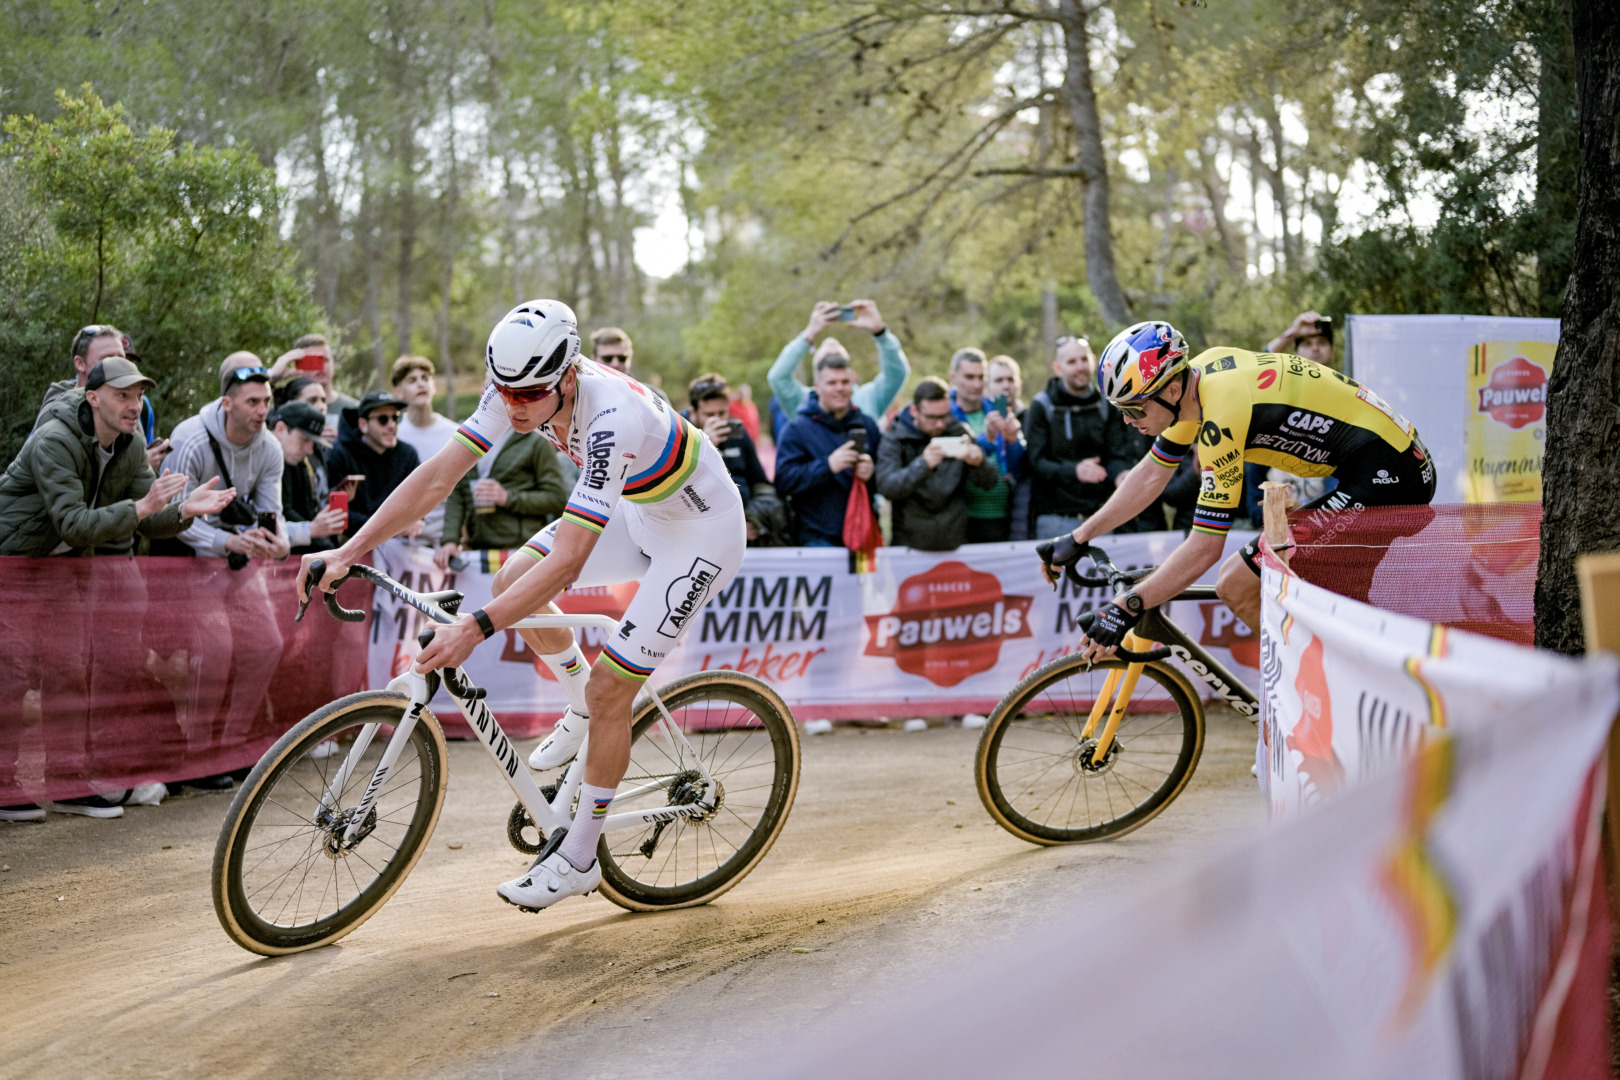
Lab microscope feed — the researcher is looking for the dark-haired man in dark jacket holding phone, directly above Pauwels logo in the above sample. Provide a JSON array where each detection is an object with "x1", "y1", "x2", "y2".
[{"x1": 876, "y1": 376, "x2": 1001, "y2": 551}]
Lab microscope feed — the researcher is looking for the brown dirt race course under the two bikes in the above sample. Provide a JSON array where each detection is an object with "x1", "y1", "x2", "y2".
[{"x1": 0, "y1": 712, "x2": 1264, "y2": 1080}]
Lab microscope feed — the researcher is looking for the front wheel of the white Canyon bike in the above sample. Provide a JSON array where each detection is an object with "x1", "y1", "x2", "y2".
[{"x1": 212, "y1": 690, "x2": 447, "y2": 955}]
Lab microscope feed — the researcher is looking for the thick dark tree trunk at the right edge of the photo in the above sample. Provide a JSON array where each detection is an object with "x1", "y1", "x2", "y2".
[{"x1": 1536, "y1": 0, "x2": 1620, "y2": 653}]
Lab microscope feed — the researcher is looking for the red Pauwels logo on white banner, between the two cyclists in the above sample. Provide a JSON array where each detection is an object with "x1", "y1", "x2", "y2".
[{"x1": 865, "y1": 560, "x2": 1032, "y2": 687}]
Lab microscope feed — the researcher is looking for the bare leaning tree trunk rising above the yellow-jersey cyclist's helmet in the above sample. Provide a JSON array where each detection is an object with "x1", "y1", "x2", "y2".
[{"x1": 1058, "y1": 0, "x2": 1131, "y2": 325}]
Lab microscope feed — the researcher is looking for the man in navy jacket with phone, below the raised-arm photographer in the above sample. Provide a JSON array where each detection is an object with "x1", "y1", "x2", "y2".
[{"x1": 776, "y1": 353, "x2": 881, "y2": 547}]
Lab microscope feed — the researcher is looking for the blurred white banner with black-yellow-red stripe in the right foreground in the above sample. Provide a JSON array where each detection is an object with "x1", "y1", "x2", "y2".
[{"x1": 751, "y1": 563, "x2": 1620, "y2": 1080}]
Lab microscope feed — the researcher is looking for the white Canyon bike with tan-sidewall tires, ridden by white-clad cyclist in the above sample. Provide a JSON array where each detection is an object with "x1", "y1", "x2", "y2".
[{"x1": 212, "y1": 562, "x2": 799, "y2": 955}]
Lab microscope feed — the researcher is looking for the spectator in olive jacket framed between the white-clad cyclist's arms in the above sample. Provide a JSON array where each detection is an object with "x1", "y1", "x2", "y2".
[{"x1": 434, "y1": 431, "x2": 569, "y2": 568}]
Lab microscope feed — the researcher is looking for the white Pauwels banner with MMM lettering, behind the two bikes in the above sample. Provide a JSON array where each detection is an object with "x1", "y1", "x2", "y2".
[{"x1": 369, "y1": 533, "x2": 1260, "y2": 735}]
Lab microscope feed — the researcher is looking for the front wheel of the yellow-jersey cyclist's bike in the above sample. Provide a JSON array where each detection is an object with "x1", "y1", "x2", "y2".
[{"x1": 974, "y1": 656, "x2": 1204, "y2": 844}]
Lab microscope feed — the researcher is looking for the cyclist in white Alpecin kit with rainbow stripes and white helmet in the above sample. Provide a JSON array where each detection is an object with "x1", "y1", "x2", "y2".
[{"x1": 300, "y1": 300, "x2": 747, "y2": 912}]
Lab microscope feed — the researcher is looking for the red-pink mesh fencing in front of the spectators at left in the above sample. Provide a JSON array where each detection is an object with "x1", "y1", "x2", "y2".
[{"x1": 0, "y1": 559, "x2": 369, "y2": 805}]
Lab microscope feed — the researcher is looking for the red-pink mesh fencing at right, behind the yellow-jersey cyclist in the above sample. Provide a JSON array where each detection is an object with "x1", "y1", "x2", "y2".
[{"x1": 1290, "y1": 502, "x2": 1541, "y2": 644}]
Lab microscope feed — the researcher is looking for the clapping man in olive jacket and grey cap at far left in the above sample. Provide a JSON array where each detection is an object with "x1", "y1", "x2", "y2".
[{"x1": 0, "y1": 356, "x2": 235, "y2": 555}]
